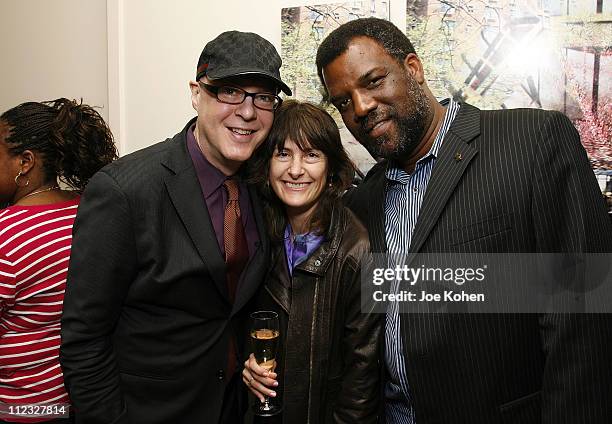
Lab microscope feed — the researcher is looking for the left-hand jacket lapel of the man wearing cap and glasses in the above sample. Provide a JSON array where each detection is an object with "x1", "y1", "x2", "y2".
[{"x1": 162, "y1": 121, "x2": 229, "y2": 302}]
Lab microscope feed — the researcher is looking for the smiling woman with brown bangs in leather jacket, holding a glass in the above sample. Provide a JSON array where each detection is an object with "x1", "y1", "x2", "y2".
[{"x1": 243, "y1": 101, "x2": 382, "y2": 423}]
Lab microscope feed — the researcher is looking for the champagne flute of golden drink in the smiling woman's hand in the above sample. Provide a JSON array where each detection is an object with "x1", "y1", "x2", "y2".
[{"x1": 251, "y1": 311, "x2": 282, "y2": 417}]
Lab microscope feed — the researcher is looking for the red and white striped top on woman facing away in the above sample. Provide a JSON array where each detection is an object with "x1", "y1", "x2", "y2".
[{"x1": 0, "y1": 197, "x2": 79, "y2": 422}]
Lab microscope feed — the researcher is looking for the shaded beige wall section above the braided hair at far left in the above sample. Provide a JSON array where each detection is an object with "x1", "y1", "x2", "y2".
[{"x1": 0, "y1": 0, "x2": 108, "y2": 119}]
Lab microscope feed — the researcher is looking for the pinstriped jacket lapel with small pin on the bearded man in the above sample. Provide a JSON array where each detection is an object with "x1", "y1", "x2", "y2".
[{"x1": 409, "y1": 103, "x2": 480, "y2": 253}]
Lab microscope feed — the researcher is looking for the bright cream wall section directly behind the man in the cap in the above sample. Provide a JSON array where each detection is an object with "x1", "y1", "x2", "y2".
[{"x1": 119, "y1": 0, "x2": 280, "y2": 153}]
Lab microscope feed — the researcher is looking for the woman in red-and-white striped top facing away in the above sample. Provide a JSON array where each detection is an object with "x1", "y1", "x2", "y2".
[{"x1": 0, "y1": 99, "x2": 117, "y2": 422}]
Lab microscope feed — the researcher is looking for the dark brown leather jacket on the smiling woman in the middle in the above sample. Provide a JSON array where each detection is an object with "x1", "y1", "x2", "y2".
[{"x1": 258, "y1": 206, "x2": 384, "y2": 424}]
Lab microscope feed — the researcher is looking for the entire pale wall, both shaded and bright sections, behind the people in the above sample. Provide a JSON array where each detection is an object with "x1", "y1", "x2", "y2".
[{"x1": 0, "y1": 0, "x2": 405, "y2": 155}]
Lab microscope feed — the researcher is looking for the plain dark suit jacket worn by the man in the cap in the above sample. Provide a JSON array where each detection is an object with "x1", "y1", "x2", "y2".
[{"x1": 60, "y1": 117, "x2": 269, "y2": 424}]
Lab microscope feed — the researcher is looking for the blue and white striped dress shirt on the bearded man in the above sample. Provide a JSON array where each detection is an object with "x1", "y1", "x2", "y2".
[{"x1": 385, "y1": 99, "x2": 459, "y2": 424}]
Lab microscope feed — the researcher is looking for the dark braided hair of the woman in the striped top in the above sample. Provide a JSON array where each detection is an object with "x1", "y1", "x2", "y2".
[{"x1": 0, "y1": 98, "x2": 117, "y2": 191}]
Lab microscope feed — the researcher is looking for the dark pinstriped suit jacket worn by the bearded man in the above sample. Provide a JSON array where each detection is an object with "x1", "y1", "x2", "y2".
[{"x1": 347, "y1": 104, "x2": 612, "y2": 424}]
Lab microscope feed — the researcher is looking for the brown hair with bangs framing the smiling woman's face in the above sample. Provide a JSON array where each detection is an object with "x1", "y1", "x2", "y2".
[{"x1": 249, "y1": 100, "x2": 355, "y2": 242}]
